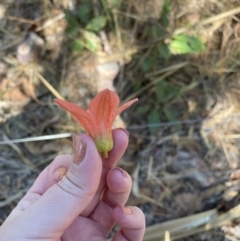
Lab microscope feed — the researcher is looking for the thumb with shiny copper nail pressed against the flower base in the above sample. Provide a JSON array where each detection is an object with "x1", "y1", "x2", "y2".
[{"x1": 15, "y1": 135, "x2": 102, "y2": 237}]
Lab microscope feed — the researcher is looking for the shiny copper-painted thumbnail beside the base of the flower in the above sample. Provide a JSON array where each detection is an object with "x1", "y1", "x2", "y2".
[{"x1": 73, "y1": 135, "x2": 86, "y2": 165}]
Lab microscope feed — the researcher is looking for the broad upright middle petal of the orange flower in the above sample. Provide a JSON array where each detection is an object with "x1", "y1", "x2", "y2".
[{"x1": 89, "y1": 89, "x2": 119, "y2": 124}]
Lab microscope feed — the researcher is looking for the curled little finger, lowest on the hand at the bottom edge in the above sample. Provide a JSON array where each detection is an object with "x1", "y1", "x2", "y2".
[{"x1": 112, "y1": 207, "x2": 146, "y2": 241}]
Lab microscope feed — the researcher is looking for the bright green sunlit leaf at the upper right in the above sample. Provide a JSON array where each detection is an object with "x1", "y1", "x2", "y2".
[{"x1": 169, "y1": 34, "x2": 205, "y2": 54}]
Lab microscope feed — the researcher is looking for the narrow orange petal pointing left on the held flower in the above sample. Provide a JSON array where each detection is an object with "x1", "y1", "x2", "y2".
[{"x1": 54, "y1": 99, "x2": 94, "y2": 134}]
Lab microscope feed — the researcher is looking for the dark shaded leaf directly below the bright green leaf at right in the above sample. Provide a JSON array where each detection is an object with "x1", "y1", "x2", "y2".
[{"x1": 156, "y1": 80, "x2": 180, "y2": 102}]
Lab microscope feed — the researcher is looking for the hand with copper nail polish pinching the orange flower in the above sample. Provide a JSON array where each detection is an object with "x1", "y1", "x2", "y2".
[{"x1": 0, "y1": 129, "x2": 145, "y2": 241}]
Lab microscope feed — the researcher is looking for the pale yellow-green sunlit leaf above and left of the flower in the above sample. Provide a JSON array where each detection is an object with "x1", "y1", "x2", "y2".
[{"x1": 83, "y1": 31, "x2": 101, "y2": 53}]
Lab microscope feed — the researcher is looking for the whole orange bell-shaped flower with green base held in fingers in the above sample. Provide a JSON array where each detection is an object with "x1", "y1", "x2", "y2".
[{"x1": 54, "y1": 89, "x2": 138, "y2": 157}]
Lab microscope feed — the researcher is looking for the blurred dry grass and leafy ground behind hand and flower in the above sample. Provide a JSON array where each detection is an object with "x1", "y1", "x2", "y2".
[{"x1": 0, "y1": 0, "x2": 240, "y2": 241}]
